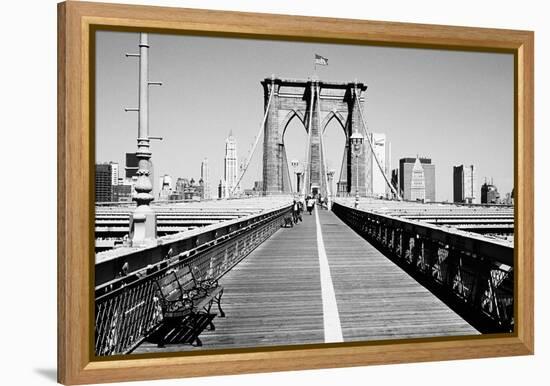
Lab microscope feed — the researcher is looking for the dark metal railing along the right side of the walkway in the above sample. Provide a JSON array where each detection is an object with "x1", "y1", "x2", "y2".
[{"x1": 332, "y1": 203, "x2": 514, "y2": 332}]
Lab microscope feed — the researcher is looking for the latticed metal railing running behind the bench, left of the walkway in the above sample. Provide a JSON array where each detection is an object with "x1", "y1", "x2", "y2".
[{"x1": 95, "y1": 207, "x2": 290, "y2": 356}]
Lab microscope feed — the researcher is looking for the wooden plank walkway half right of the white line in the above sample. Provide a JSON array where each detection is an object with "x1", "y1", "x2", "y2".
[{"x1": 319, "y1": 211, "x2": 478, "y2": 341}]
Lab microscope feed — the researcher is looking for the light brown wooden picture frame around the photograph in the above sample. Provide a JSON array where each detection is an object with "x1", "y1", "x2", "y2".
[{"x1": 58, "y1": 1, "x2": 534, "y2": 384}]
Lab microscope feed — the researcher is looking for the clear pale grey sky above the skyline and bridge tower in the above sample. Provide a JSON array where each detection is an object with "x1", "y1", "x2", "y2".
[{"x1": 96, "y1": 31, "x2": 514, "y2": 201}]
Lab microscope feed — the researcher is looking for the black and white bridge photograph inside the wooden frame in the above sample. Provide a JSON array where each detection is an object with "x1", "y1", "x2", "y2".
[{"x1": 91, "y1": 29, "x2": 515, "y2": 357}]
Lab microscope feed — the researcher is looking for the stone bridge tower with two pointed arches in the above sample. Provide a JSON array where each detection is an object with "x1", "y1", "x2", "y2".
[{"x1": 261, "y1": 78, "x2": 372, "y2": 197}]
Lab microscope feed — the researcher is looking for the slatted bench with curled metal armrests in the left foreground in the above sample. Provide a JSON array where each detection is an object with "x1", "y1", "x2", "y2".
[{"x1": 156, "y1": 266, "x2": 225, "y2": 347}]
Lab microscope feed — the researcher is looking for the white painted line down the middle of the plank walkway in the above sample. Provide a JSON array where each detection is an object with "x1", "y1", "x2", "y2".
[{"x1": 315, "y1": 206, "x2": 344, "y2": 343}]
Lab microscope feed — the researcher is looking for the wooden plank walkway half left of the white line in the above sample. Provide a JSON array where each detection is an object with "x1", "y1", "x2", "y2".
[{"x1": 134, "y1": 213, "x2": 324, "y2": 353}]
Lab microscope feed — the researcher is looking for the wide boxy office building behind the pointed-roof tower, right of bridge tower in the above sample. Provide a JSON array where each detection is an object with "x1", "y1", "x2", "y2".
[{"x1": 399, "y1": 157, "x2": 435, "y2": 201}]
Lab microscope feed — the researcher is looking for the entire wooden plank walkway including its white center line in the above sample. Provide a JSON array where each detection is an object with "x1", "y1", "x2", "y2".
[{"x1": 134, "y1": 205, "x2": 478, "y2": 353}]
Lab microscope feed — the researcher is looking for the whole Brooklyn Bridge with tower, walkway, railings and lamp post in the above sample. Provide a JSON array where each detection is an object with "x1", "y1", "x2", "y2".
[{"x1": 95, "y1": 34, "x2": 514, "y2": 355}]
